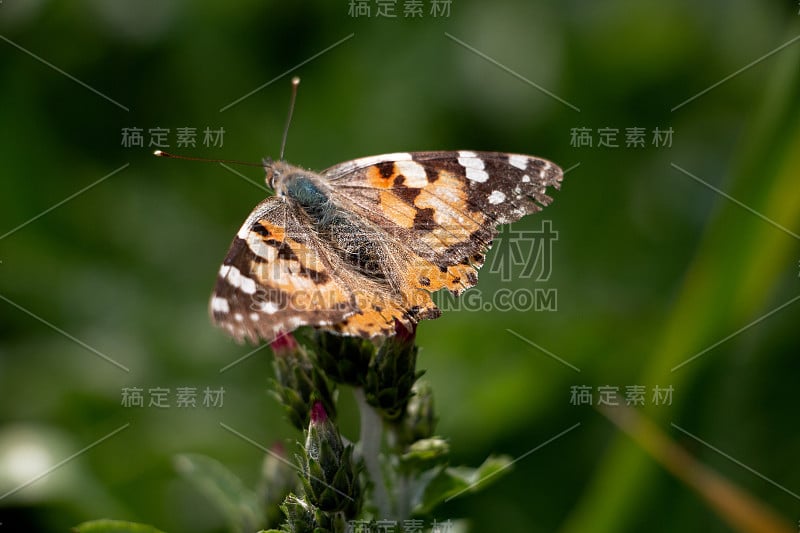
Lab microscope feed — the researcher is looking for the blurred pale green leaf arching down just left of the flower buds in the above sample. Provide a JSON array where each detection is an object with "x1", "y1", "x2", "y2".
[{"x1": 175, "y1": 454, "x2": 264, "y2": 532}]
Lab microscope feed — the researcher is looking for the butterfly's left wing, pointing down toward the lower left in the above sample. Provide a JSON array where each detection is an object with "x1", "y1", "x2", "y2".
[{"x1": 210, "y1": 197, "x2": 370, "y2": 342}]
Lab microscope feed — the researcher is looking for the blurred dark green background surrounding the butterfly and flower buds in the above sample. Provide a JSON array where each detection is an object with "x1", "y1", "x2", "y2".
[{"x1": 0, "y1": 0, "x2": 800, "y2": 533}]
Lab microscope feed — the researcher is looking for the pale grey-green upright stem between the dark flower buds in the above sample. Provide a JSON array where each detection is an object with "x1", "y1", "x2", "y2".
[{"x1": 353, "y1": 388, "x2": 391, "y2": 519}]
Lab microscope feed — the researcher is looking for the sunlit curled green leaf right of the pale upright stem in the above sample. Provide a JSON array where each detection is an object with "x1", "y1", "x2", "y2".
[{"x1": 412, "y1": 455, "x2": 512, "y2": 514}]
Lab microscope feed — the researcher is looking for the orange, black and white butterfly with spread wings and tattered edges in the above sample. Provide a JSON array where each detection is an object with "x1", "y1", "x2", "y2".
[{"x1": 210, "y1": 150, "x2": 563, "y2": 342}]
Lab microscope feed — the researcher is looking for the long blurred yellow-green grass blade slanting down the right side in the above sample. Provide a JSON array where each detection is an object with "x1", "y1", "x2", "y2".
[{"x1": 564, "y1": 27, "x2": 800, "y2": 533}]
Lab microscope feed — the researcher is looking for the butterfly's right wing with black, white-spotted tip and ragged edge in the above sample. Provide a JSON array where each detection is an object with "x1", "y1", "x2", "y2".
[{"x1": 322, "y1": 150, "x2": 563, "y2": 293}]
